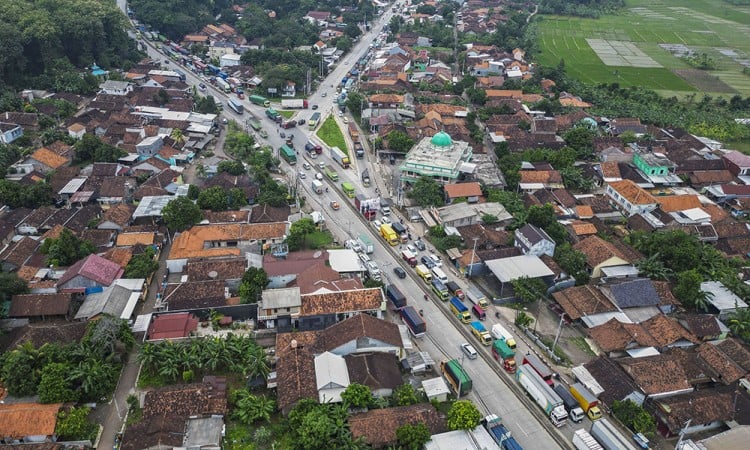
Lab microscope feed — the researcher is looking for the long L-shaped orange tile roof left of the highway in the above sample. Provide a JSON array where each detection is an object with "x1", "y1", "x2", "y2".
[{"x1": 169, "y1": 222, "x2": 287, "y2": 259}]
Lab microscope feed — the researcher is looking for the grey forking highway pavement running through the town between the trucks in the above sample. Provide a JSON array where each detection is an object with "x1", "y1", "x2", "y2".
[{"x1": 118, "y1": 0, "x2": 582, "y2": 449}]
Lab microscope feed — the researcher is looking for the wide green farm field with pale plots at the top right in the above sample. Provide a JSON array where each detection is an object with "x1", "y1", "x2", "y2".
[{"x1": 539, "y1": 0, "x2": 750, "y2": 97}]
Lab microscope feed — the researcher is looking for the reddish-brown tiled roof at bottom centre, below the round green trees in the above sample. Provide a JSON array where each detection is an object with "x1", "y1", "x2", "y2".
[{"x1": 349, "y1": 403, "x2": 446, "y2": 448}]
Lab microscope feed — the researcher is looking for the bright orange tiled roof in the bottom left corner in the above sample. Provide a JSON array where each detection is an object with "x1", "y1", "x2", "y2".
[{"x1": 0, "y1": 403, "x2": 62, "y2": 439}]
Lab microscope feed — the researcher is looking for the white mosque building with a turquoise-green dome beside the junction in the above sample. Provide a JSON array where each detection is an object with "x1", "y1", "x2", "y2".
[{"x1": 399, "y1": 131, "x2": 473, "y2": 184}]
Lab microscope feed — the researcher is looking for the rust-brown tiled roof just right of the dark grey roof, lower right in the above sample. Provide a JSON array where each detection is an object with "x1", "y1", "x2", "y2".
[{"x1": 618, "y1": 355, "x2": 690, "y2": 395}]
